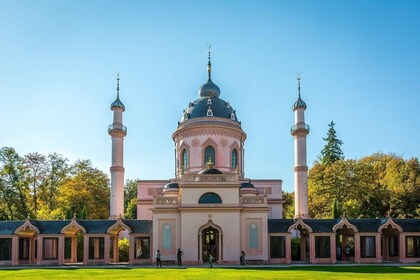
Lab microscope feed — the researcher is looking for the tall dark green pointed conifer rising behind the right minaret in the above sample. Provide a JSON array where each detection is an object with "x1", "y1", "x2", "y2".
[{"x1": 321, "y1": 121, "x2": 344, "y2": 165}]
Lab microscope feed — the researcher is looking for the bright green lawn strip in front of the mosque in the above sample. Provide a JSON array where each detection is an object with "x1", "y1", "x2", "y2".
[{"x1": 0, "y1": 266, "x2": 420, "y2": 280}]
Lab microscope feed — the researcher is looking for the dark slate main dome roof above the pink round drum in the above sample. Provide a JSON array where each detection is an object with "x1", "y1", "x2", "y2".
[{"x1": 181, "y1": 97, "x2": 238, "y2": 123}]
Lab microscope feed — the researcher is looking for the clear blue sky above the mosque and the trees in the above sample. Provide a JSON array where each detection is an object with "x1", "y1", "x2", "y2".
[{"x1": 0, "y1": 0, "x2": 420, "y2": 191}]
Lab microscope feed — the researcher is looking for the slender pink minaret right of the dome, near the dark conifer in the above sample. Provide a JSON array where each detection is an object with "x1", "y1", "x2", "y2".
[{"x1": 290, "y1": 76, "x2": 309, "y2": 218}]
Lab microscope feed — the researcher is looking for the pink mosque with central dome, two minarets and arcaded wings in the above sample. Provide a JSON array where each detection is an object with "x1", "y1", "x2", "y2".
[{"x1": 0, "y1": 51, "x2": 420, "y2": 266}]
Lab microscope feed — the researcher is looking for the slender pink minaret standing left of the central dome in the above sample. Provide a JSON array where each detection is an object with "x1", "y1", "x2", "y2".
[{"x1": 108, "y1": 74, "x2": 127, "y2": 219}]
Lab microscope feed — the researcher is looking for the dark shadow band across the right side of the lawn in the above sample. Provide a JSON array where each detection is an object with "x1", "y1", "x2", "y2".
[{"x1": 220, "y1": 266, "x2": 420, "y2": 274}]
